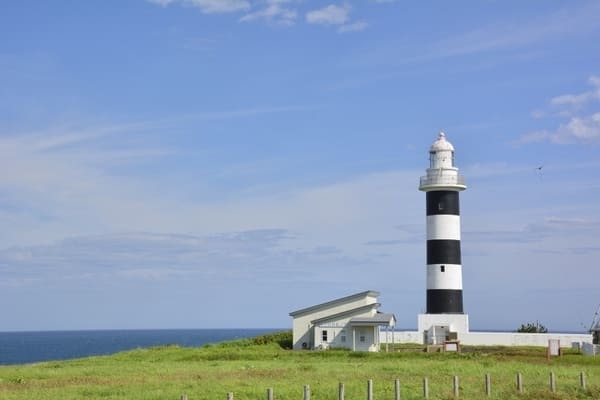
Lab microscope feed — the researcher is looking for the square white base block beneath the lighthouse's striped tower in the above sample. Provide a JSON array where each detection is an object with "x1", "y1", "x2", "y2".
[{"x1": 417, "y1": 314, "x2": 469, "y2": 344}]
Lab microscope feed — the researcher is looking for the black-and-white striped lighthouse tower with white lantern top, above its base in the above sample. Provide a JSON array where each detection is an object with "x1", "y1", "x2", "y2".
[{"x1": 419, "y1": 132, "x2": 467, "y2": 314}]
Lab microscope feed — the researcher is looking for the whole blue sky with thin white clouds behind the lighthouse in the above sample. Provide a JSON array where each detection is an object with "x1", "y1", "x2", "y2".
[{"x1": 0, "y1": 0, "x2": 600, "y2": 332}]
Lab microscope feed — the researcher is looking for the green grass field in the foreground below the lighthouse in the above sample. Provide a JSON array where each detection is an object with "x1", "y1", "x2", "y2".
[{"x1": 0, "y1": 332, "x2": 600, "y2": 400}]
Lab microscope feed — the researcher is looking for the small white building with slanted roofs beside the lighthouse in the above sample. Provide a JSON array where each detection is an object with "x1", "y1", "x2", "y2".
[{"x1": 290, "y1": 290, "x2": 396, "y2": 351}]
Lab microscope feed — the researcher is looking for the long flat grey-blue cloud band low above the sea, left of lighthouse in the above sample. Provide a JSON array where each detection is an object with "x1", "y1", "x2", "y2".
[{"x1": 0, "y1": 229, "x2": 372, "y2": 287}]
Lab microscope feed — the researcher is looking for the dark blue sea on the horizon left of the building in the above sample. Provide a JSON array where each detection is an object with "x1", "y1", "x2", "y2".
[{"x1": 0, "y1": 329, "x2": 278, "y2": 365}]
